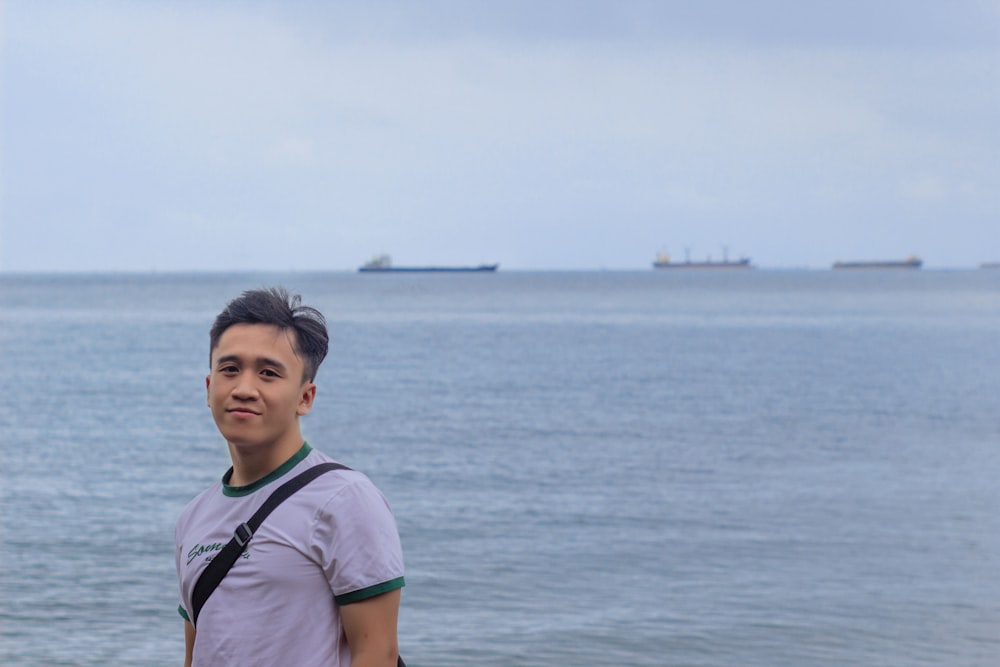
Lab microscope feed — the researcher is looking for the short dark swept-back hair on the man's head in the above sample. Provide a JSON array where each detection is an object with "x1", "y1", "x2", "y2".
[{"x1": 209, "y1": 287, "x2": 330, "y2": 382}]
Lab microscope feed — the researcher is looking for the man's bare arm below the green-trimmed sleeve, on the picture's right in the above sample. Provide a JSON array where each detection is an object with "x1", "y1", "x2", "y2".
[{"x1": 342, "y1": 589, "x2": 400, "y2": 667}]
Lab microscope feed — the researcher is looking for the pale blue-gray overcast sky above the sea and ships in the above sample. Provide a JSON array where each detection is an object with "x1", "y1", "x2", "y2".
[{"x1": 0, "y1": 0, "x2": 1000, "y2": 271}]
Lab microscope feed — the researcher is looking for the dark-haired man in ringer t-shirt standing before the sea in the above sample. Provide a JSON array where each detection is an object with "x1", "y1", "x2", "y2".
[{"x1": 175, "y1": 288, "x2": 404, "y2": 667}]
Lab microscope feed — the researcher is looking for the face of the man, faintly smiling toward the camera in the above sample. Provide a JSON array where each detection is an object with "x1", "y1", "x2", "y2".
[{"x1": 205, "y1": 324, "x2": 316, "y2": 449}]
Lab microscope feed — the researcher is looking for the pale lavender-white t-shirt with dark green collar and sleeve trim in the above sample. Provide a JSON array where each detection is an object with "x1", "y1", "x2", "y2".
[{"x1": 174, "y1": 444, "x2": 404, "y2": 667}]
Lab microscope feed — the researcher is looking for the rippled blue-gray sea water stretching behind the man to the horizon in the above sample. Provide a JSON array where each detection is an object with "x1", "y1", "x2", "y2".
[{"x1": 0, "y1": 271, "x2": 1000, "y2": 667}]
